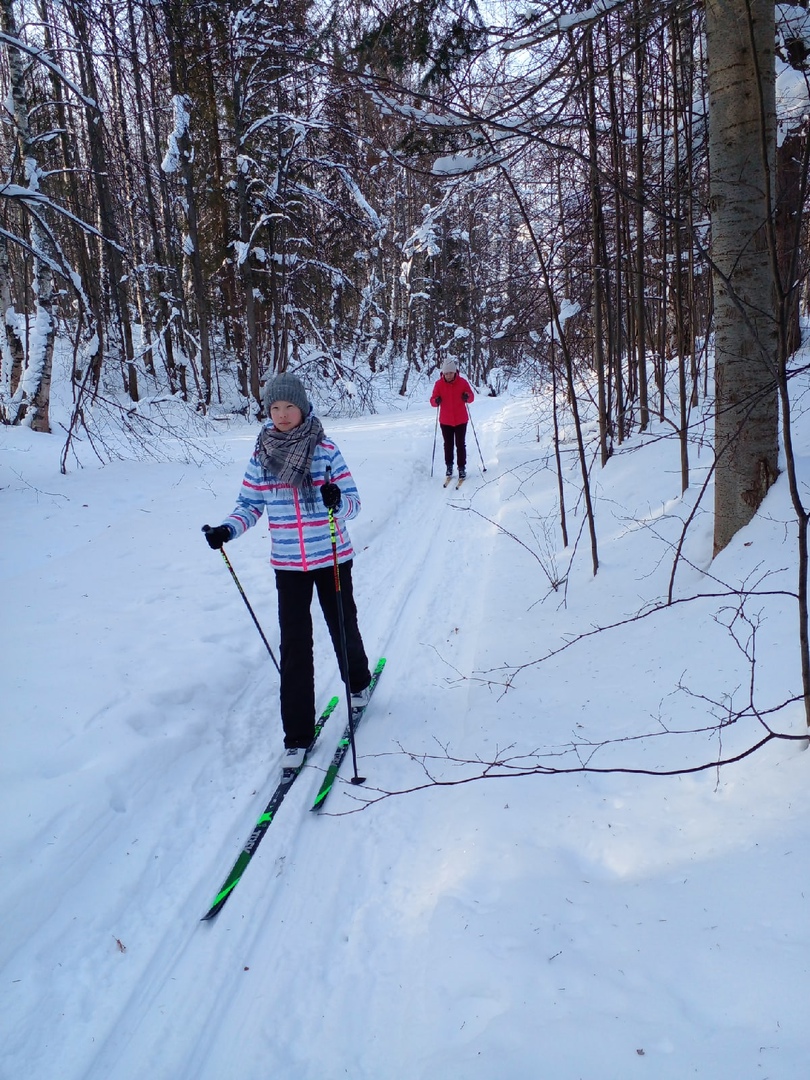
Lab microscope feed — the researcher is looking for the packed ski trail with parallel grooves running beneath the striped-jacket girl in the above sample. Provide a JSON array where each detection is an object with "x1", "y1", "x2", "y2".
[{"x1": 65, "y1": 403, "x2": 514, "y2": 1080}]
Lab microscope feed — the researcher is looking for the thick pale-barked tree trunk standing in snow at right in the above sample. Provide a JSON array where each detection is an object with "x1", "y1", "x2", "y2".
[{"x1": 706, "y1": 0, "x2": 779, "y2": 554}]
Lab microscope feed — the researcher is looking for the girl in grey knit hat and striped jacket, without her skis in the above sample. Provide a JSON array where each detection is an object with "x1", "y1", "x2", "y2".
[{"x1": 204, "y1": 373, "x2": 372, "y2": 769}]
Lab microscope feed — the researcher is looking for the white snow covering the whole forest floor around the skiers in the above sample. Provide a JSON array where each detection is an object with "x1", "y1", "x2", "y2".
[{"x1": 0, "y1": 369, "x2": 810, "y2": 1080}]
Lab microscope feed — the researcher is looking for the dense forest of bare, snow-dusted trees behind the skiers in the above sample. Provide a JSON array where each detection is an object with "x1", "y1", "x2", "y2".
[{"x1": 0, "y1": 0, "x2": 810, "y2": 548}]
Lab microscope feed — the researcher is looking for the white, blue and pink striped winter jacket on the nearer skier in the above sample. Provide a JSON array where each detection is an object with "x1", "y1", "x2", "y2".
[{"x1": 222, "y1": 421, "x2": 360, "y2": 570}]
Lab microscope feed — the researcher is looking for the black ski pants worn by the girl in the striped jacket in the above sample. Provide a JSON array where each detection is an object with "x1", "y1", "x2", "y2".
[{"x1": 275, "y1": 559, "x2": 372, "y2": 748}]
